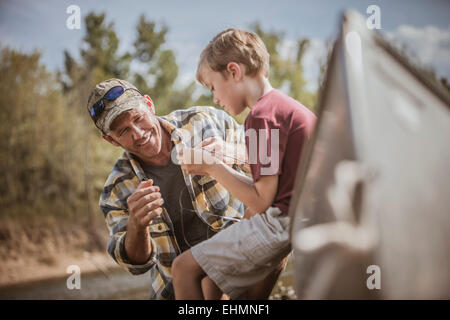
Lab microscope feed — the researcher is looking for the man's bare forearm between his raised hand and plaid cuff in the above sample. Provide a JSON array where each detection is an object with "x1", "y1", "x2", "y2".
[{"x1": 125, "y1": 224, "x2": 152, "y2": 264}]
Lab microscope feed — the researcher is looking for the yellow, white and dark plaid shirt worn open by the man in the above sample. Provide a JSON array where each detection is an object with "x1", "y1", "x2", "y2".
[{"x1": 99, "y1": 107, "x2": 245, "y2": 299}]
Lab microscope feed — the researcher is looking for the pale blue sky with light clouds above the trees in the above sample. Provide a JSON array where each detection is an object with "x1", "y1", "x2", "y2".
[{"x1": 0, "y1": 0, "x2": 450, "y2": 90}]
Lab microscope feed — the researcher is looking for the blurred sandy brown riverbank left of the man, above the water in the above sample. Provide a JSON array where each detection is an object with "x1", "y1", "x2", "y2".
[{"x1": 0, "y1": 219, "x2": 111, "y2": 286}]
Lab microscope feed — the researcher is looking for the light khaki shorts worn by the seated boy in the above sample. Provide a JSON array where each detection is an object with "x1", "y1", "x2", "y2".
[{"x1": 191, "y1": 207, "x2": 291, "y2": 299}]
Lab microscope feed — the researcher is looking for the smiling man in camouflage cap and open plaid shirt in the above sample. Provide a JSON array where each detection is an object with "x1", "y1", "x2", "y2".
[{"x1": 87, "y1": 79, "x2": 245, "y2": 299}]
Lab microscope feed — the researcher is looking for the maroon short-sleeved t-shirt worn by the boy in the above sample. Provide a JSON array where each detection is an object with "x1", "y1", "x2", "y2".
[{"x1": 245, "y1": 89, "x2": 316, "y2": 215}]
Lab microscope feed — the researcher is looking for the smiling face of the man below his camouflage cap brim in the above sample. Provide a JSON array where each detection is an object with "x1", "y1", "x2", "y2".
[{"x1": 109, "y1": 107, "x2": 163, "y2": 159}]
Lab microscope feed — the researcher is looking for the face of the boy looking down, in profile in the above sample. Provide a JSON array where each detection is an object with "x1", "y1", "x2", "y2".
[{"x1": 202, "y1": 68, "x2": 246, "y2": 116}]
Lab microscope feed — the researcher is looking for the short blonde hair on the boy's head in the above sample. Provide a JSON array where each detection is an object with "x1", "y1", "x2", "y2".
[{"x1": 196, "y1": 29, "x2": 269, "y2": 83}]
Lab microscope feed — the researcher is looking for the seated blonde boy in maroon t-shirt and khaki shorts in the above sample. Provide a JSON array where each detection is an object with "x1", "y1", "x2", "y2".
[{"x1": 172, "y1": 29, "x2": 316, "y2": 299}]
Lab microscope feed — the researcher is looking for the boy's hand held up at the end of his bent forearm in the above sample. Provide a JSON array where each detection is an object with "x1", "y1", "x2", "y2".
[{"x1": 178, "y1": 148, "x2": 220, "y2": 175}]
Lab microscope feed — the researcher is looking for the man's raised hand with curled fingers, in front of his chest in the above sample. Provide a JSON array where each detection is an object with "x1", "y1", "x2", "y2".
[{"x1": 127, "y1": 180, "x2": 164, "y2": 231}]
